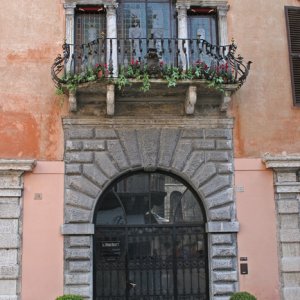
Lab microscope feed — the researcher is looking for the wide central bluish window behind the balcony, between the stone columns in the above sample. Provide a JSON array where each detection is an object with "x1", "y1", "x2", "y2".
[{"x1": 118, "y1": 0, "x2": 176, "y2": 64}]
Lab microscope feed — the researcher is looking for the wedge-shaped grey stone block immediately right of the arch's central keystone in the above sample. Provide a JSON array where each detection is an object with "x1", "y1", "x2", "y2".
[{"x1": 158, "y1": 129, "x2": 180, "y2": 167}]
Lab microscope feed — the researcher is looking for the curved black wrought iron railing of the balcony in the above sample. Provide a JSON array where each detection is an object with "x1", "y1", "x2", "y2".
[{"x1": 51, "y1": 37, "x2": 251, "y2": 87}]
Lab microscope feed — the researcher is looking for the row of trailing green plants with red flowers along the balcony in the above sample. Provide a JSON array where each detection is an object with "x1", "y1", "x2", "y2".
[{"x1": 56, "y1": 60, "x2": 237, "y2": 95}]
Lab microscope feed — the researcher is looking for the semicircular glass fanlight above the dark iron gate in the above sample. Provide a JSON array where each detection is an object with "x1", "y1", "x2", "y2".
[{"x1": 96, "y1": 173, "x2": 203, "y2": 225}]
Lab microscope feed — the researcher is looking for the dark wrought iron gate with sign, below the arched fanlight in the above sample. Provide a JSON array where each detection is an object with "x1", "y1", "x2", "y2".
[{"x1": 94, "y1": 224, "x2": 208, "y2": 300}]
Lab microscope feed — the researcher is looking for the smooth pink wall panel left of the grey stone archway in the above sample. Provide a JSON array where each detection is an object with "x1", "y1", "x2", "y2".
[{"x1": 22, "y1": 162, "x2": 64, "y2": 300}]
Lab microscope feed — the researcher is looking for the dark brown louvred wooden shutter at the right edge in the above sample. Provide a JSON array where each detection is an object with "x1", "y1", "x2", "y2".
[{"x1": 285, "y1": 6, "x2": 300, "y2": 106}]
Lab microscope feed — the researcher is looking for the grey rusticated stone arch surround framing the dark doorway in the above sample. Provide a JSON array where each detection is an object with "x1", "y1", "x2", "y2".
[{"x1": 62, "y1": 120, "x2": 238, "y2": 299}]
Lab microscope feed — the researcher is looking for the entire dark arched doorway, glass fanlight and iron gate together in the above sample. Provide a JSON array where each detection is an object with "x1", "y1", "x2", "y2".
[{"x1": 94, "y1": 172, "x2": 208, "y2": 300}]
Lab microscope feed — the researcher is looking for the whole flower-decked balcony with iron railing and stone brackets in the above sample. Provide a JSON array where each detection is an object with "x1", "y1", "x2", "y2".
[{"x1": 51, "y1": 37, "x2": 251, "y2": 116}]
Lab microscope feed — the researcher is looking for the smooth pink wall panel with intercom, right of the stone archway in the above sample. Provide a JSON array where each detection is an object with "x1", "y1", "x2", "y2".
[{"x1": 235, "y1": 159, "x2": 280, "y2": 300}]
